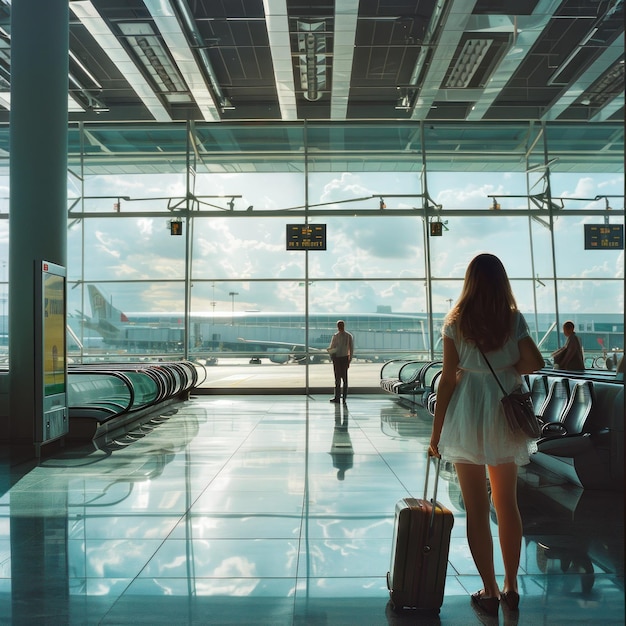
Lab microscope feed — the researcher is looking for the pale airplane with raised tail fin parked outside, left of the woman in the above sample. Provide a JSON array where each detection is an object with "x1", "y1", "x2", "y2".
[{"x1": 79, "y1": 284, "x2": 436, "y2": 363}]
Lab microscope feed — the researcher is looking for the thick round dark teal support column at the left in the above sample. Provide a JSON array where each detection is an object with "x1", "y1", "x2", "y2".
[{"x1": 6, "y1": 0, "x2": 69, "y2": 444}]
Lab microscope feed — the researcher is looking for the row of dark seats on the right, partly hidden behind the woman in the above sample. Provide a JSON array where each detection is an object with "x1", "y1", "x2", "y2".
[{"x1": 381, "y1": 361, "x2": 624, "y2": 489}]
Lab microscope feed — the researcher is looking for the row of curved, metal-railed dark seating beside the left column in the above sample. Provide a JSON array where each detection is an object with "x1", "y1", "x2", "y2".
[{"x1": 67, "y1": 361, "x2": 206, "y2": 440}]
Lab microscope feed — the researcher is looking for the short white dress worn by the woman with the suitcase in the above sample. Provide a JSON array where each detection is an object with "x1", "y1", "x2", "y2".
[{"x1": 439, "y1": 312, "x2": 532, "y2": 465}]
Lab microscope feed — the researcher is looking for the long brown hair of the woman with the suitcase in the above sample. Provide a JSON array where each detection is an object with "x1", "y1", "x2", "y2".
[{"x1": 445, "y1": 254, "x2": 517, "y2": 352}]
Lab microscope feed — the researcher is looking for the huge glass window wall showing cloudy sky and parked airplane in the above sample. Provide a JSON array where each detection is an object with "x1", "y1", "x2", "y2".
[{"x1": 0, "y1": 122, "x2": 624, "y2": 389}]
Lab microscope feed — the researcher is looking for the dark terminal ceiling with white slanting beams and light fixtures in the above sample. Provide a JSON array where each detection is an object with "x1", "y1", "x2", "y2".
[{"x1": 0, "y1": 0, "x2": 624, "y2": 165}]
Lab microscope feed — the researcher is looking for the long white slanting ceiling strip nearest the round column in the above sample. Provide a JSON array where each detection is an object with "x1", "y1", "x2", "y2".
[{"x1": 70, "y1": 0, "x2": 172, "y2": 122}]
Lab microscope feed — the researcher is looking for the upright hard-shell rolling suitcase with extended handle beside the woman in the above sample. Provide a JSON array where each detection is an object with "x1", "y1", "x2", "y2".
[{"x1": 387, "y1": 457, "x2": 454, "y2": 613}]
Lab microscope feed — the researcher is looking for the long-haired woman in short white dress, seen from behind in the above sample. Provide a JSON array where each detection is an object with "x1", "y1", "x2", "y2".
[{"x1": 429, "y1": 254, "x2": 544, "y2": 615}]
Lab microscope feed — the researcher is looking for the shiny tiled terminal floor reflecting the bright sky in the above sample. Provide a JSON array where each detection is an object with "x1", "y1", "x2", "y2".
[{"x1": 0, "y1": 394, "x2": 624, "y2": 626}]
